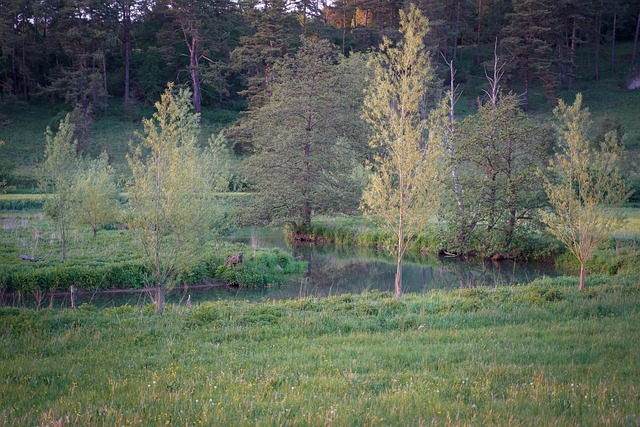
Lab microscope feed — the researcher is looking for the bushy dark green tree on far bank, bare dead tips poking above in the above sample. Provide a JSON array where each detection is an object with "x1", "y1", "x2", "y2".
[{"x1": 441, "y1": 92, "x2": 549, "y2": 257}]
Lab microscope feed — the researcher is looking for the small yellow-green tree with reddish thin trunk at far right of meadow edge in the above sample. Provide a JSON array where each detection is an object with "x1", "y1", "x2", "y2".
[{"x1": 542, "y1": 94, "x2": 630, "y2": 290}]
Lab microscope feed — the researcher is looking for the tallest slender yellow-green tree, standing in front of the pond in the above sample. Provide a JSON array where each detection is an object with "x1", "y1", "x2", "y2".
[{"x1": 362, "y1": 5, "x2": 439, "y2": 298}]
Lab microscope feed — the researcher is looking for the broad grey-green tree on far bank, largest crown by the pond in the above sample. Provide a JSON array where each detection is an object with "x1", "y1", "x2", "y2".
[{"x1": 241, "y1": 39, "x2": 366, "y2": 226}]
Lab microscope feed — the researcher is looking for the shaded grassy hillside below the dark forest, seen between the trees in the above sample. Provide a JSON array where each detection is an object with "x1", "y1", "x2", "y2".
[{"x1": 0, "y1": 44, "x2": 640, "y2": 197}]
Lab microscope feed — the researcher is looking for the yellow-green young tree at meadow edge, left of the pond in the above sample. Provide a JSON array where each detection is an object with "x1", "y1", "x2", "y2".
[{"x1": 127, "y1": 85, "x2": 210, "y2": 314}]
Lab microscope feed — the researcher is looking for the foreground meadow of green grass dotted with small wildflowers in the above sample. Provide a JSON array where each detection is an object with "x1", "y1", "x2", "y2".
[{"x1": 0, "y1": 278, "x2": 640, "y2": 425}]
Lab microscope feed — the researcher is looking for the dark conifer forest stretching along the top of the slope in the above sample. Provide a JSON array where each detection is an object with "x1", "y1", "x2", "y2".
[{"x1": 0, "y1": 0, "x2": 640, "y2": 112}]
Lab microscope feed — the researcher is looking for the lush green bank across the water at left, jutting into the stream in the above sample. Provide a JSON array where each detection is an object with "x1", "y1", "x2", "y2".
[{"x1": 0, "y1": 193, "x2": 306, "y2": 296}]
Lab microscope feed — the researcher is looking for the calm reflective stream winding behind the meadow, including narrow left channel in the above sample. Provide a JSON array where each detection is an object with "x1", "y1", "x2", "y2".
[{"x1": 4, "y1": 228, "x2": 559, "y2": 308}]
